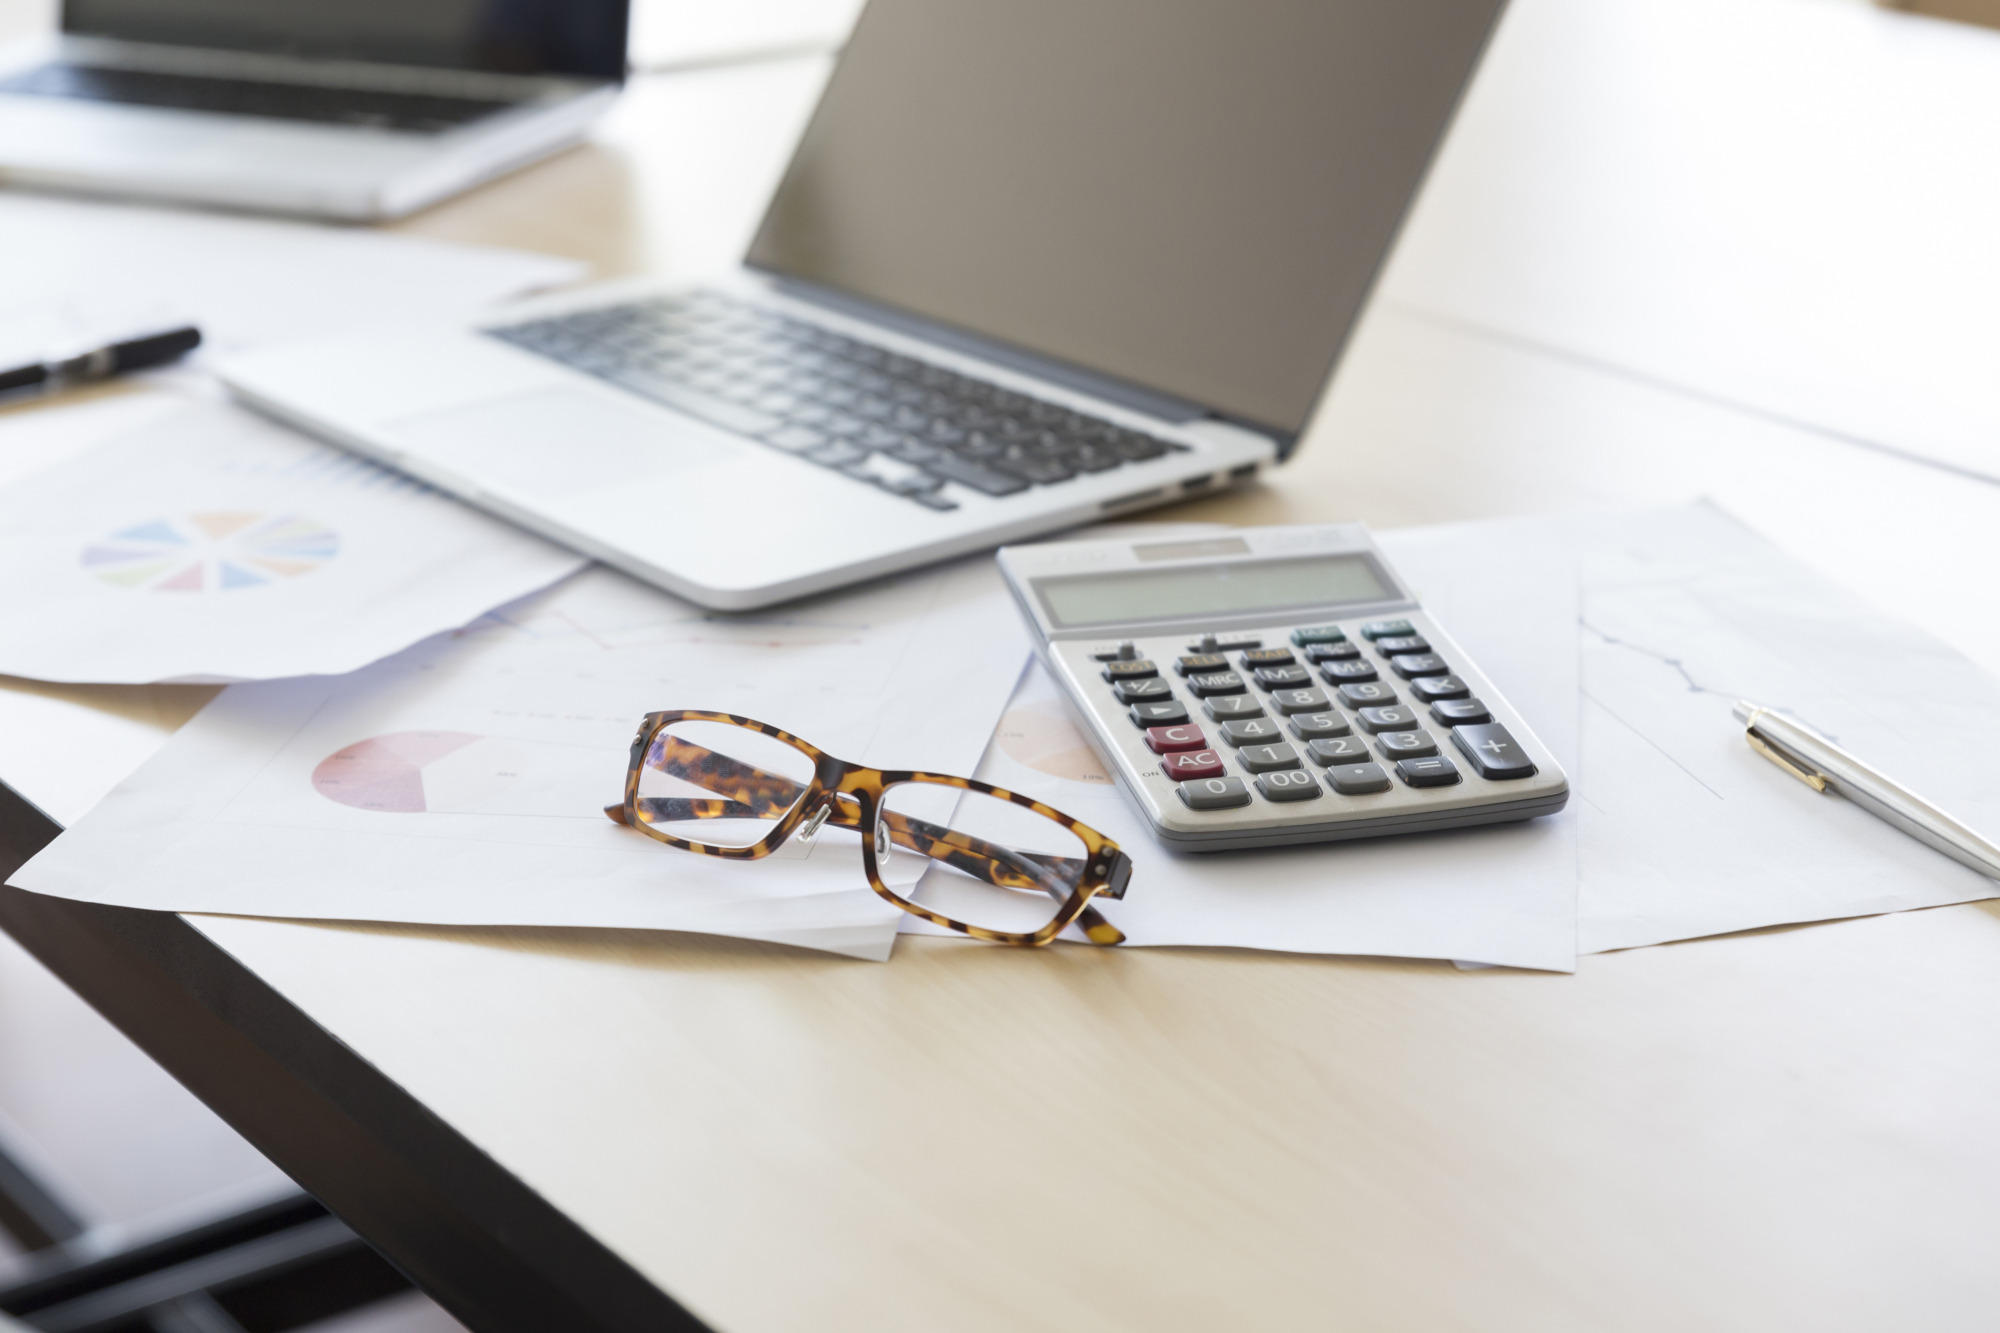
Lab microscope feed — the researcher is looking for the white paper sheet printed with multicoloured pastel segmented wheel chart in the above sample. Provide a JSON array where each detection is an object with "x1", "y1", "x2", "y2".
[{"x1": 0, "y1": 402, "x2": 584, "y2": 685}]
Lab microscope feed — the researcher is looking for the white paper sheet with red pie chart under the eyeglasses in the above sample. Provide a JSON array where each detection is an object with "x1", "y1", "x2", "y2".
[{"x1": 12, "y1": 548, "x2": 1028, "y2": 959}]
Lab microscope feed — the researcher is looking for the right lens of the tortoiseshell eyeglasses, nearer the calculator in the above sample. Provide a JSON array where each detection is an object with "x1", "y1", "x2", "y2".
[{"x1": 876, "y1": 783, "x2": 1090, "y2": 935}]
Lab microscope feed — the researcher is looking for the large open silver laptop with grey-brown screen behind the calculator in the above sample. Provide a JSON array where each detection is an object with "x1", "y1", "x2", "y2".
[{"x1": 220, "y1": 0, "x2": 1504, "y2": 610}]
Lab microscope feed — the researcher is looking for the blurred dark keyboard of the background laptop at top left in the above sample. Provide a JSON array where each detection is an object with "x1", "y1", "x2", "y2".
[{"x1": 0, "y1": 64, "x2": 514, "y2": 132}]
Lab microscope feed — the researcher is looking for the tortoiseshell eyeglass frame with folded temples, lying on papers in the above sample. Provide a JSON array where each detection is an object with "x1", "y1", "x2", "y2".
[{"x1": 604, "y1": 709, "x2": 1132, "y2": 945}]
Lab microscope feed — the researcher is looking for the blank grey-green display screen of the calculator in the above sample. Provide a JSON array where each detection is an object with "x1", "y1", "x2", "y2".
[{"x1": 1034, "y1": 554, "x2": 1396, "y2": 628}]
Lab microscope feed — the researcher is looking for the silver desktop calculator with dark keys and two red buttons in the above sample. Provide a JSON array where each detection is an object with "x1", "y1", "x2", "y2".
[{"x1": 1000, "y1": 524, "x2": 1570, "y2": 851}]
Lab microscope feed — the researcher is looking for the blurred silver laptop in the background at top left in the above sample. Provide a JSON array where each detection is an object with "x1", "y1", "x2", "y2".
[{"x1": 0, "y1": 0, "x2": 628, "y2": 220}]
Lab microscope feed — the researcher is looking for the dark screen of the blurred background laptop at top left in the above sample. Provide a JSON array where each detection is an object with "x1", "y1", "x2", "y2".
[{"x1": 62, "y1": 0, "x2": 628, "y2": 80}]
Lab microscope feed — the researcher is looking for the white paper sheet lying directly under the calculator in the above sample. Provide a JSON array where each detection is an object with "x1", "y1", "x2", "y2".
[{"x1": 904, "y1": 520, "x2": 1576, "y2": 971}]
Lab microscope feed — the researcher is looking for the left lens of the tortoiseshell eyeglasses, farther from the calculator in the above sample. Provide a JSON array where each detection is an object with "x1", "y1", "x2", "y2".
[{"x1": 634, "y1": 719, "x2": 812, "y2": 847}]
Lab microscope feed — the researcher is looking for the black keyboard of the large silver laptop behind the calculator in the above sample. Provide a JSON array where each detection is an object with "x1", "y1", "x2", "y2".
[{"x1": 486, "y1": 292, "x2": 1188, "y2": 510}]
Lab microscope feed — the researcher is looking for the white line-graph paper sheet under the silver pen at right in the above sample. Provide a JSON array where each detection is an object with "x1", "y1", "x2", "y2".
[{"x1": 1570, "y1": 504, "x2": 2000, "y2": 953}]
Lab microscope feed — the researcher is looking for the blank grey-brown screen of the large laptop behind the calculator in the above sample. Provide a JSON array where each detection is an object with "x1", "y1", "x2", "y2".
[{"x1": 748, "y1": 0, "x2": 1504, "y2": 434}]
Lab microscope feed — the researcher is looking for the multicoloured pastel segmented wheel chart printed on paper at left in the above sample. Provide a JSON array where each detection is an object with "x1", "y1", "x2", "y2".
[{"x1": 80, "y1": 510, "x2": 340, "y2": 592}]
